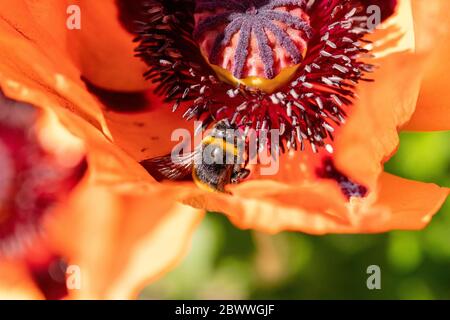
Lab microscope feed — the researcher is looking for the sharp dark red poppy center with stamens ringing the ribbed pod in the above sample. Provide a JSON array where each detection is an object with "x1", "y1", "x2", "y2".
[{"x1": 131, "y1": 0, "x2": 396, "y2": 196}]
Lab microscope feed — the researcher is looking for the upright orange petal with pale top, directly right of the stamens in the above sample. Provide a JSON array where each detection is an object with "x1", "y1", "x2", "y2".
[{"x1": 335, "y1": 0, "x2": 423, "y2": 189}]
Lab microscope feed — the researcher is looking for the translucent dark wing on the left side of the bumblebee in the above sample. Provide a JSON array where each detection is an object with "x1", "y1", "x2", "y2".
[{"x1": 140, "y1": 153, "x2": 194, "y2": 181}]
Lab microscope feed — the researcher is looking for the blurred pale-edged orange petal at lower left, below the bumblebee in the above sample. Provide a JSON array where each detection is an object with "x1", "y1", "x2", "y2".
[{"x1": 45, "y1": 181, "x2": 203, "y2": 299}]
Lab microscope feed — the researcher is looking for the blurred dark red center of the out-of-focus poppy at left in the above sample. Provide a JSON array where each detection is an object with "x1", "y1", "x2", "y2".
[{"x1": 0, "y1": 93, "x2": 86, "y2": 258}]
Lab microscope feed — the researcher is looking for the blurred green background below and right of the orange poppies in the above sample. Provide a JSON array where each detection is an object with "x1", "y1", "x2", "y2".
[{"x1": 141, "y1": 132, "x2": 450, "y2": 299}]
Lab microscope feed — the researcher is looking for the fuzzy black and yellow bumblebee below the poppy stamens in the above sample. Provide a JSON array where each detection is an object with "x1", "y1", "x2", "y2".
[{"x1": 141, "y1": 120, "x2": 250, "y2": 192}]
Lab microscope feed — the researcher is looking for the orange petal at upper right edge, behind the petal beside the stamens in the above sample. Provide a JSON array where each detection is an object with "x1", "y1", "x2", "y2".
[{"x1": 404, "y1": 0, "x2": 450, "y2": 131}]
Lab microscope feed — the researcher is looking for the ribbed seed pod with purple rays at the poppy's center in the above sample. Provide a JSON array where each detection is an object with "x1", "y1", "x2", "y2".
[{"x1": 194, "y1": 0, "x2": 312, "y2": 92}]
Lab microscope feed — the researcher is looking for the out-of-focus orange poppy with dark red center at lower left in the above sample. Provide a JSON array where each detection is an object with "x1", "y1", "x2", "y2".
[{"x1": 0, "y1": 95, "x2": 199, "y2": 299}]
